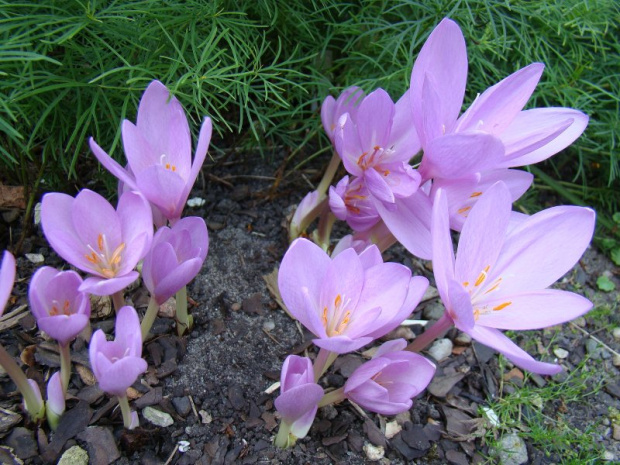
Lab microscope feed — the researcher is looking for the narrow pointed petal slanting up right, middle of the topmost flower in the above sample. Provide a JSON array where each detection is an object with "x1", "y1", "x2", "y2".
[{"x1": 455, "y1": 63, "x2": 545, "y2": 134}]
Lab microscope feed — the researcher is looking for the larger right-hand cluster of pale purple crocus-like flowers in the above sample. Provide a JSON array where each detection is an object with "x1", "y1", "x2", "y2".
[{"x1": 276, "y1": 19, "x2": 595, "y2": 447}]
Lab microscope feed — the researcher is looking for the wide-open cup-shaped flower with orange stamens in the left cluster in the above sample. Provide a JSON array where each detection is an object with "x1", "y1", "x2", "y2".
[{"x1": 41, "y1": 189, "x2": 153, "y2": 295}]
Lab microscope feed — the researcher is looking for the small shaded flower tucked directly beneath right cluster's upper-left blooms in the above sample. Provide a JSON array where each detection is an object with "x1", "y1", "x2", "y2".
[{"x1": 329, "y1": 176, "x2": 380, "y2": 231}]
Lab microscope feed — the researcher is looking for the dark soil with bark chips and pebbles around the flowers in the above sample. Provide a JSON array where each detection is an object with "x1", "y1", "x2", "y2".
[{"x1": 0, "y1": 150, "x2": 620, "y2": 464}]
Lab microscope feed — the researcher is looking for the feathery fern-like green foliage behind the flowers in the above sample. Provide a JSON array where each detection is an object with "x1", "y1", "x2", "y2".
[{"x1": 0, "y1": 0, "x2": 620, "y2": 216}]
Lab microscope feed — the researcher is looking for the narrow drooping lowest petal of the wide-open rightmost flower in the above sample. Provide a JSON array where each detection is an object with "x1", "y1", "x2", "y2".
[{"x1": 467, "y1": 325, "x2": 562, "y2": 375}]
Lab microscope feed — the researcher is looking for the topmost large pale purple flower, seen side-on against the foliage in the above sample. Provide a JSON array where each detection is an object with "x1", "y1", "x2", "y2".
[{"x1": 409, "y1": 19, "x2": 588, "y2": 180}]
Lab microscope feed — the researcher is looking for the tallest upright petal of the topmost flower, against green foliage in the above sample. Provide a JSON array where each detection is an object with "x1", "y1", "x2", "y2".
[{"x1": 411, "y1": 18, "x2": 467, "y2": 138}]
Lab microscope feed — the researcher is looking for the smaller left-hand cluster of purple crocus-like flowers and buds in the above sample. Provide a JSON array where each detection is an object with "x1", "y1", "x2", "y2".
[{"x1": 0, "y1": 81, "x2": 211, "y2": 428}]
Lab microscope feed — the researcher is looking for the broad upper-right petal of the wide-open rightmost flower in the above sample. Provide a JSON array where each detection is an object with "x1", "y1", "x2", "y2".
[{"x1": 488, "y1": 206, "x2": 595, "y2": 297}]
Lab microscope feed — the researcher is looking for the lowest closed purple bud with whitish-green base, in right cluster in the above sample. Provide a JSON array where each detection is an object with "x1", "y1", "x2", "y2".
[{"x1": 274, "y1": 355, "x2": 323, "y2": 447}]
